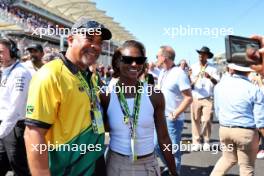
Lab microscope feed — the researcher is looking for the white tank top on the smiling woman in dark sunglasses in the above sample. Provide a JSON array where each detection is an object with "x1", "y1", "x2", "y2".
[{"x1": 107, "y1": 84, "x2": 155, "y2": 156}]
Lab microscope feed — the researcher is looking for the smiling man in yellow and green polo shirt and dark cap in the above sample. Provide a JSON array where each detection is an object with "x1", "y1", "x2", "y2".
[{"x1": 25, "y1": 18, "x2": 112, "y2": 176}]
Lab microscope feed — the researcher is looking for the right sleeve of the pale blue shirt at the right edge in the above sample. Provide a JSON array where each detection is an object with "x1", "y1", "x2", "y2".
[{"x1": 253, "y1": 89, "x2": 264, "y2": 128}]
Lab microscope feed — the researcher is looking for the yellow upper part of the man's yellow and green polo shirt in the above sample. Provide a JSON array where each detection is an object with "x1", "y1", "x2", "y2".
[{"x1": 26, "y1": 59, "x2": 91, "y2": 144}]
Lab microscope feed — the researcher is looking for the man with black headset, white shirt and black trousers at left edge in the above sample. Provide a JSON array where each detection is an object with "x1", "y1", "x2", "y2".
[{"x1": 0, "y1": 38, "x2": 31, "y2": 176}]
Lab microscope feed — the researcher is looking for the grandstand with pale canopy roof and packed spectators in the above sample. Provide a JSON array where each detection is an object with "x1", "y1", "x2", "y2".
[{"x1": 0, "y1": 0, "x2": 135, "y2": 65}]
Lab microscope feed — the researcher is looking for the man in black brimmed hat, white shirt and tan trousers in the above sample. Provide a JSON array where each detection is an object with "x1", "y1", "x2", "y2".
[{"x1": 191, "y1": 46, "x2": 219, "y2": 151}]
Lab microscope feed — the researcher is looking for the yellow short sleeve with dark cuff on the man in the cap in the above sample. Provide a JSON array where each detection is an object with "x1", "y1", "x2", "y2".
[{"x1": 25, "y1": 68, "x2": 60, "y2": 129}]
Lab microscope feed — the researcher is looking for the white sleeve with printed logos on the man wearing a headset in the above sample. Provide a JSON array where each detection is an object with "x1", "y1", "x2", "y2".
[{"x1": 0, "y1": 71, "x2": 31, "y2": 138}]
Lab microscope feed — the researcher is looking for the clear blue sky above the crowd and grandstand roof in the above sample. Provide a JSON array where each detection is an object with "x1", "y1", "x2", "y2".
[{"x1": 94, "y1": 0, "x2": 264, "y2": 63}]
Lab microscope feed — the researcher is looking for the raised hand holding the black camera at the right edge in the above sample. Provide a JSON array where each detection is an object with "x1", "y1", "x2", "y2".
[{"x1": 248, "y1": 35, "x2": 264, "y2": 75}]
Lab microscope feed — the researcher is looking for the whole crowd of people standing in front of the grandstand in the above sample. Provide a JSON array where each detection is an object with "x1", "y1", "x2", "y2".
[{"x1": 0, "y1": 18, "x2": 264, "y2": 176}]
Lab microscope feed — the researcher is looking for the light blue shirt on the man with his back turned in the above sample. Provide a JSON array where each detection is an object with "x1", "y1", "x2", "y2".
[{"x1": 214, "y1": 74, "x2": 264, "y2": 128}]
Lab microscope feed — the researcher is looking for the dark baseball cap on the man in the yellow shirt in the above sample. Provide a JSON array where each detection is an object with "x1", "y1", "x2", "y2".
[{"x1": 72, "y1": 17, "x2": 112, "y2": 40}]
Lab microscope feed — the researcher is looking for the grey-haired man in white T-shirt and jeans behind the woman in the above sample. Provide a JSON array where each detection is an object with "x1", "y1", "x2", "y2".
[{"x1": 156, "y1": 46, "x2": 192, "y2": 174}]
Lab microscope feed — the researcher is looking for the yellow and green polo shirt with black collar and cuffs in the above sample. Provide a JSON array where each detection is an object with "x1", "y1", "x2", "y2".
[{"x1": 25, "y1": 58, "x2": 104, "y2": 176}]
